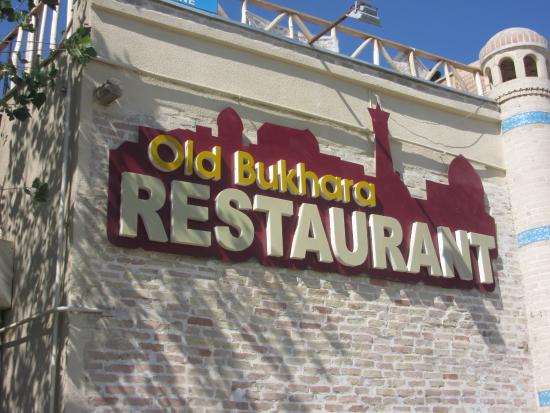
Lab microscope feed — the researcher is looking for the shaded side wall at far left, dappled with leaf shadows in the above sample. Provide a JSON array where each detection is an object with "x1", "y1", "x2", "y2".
[{"x1": 0, "y1": 56, "x2": 84, "y2": 412}]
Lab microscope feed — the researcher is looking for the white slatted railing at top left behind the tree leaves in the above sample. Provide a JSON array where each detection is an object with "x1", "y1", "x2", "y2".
[{"x1": 0, "y1": 0, "x2": 73, "y2": 96}]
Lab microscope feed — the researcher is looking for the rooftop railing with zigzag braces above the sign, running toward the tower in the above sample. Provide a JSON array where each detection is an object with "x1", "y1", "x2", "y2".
[{"x1": 218, "y1": 0, "x2": 487, "y2": 95}]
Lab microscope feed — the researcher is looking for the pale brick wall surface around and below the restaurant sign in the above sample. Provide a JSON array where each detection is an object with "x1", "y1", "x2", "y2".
[{"x1": 63, "y1": 101, "x2": 535, "y2": 413}]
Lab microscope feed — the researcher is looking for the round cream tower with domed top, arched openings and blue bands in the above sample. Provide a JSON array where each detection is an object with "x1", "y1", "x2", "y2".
[{"x1": 479, "y1": 28, "x2": 550, "y2": 412}]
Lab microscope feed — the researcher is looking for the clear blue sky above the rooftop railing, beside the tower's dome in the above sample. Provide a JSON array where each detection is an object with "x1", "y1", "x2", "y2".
[{"x1": 221, "y1": 0, "x2": 550, "y2": 63}]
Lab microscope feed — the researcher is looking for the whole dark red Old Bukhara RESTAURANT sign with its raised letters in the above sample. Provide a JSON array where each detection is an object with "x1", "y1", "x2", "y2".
[{"x1": 107, "y1": 107, "x2": 496, "y2": 291}]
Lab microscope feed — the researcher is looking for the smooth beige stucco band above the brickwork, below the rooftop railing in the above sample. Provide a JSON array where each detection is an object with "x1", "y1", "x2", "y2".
[{"x1": 92, "y1": 1, "x2": 502, "y2": 170}]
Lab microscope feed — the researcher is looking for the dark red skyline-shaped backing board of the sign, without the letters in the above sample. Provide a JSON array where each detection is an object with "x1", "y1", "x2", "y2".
[{"x1": 107, "y1": 107, "x2": 496, "y2": 291}]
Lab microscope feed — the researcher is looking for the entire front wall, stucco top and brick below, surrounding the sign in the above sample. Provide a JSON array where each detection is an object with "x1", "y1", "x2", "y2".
[{"x1": 56, "y1": 1, "x2": 535, "y2": 413}]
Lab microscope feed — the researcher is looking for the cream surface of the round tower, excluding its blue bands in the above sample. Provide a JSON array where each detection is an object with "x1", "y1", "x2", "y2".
[{"x1": 486, "y1": 43, "x2": 550, "y2": 412}]
